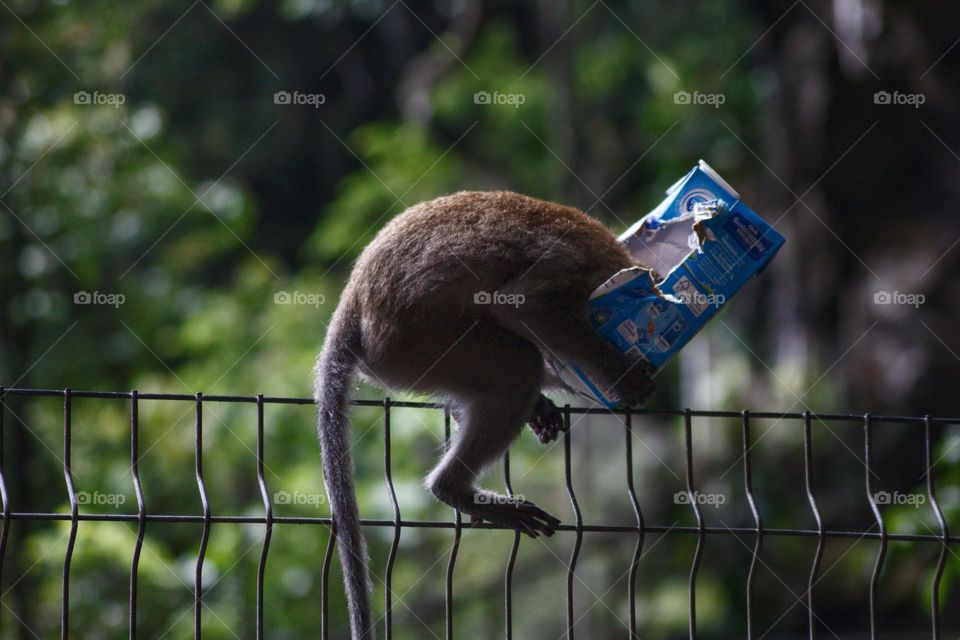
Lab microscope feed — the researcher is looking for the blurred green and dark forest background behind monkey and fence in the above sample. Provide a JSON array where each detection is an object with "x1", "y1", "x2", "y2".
[{"x1": 0, "y1": 0, "x2": 960, "y2": 639}]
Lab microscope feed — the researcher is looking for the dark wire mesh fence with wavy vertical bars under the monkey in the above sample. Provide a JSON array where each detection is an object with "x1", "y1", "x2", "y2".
[{"x1": 0, "y1": 387, "x2": 960, "y2": 640}]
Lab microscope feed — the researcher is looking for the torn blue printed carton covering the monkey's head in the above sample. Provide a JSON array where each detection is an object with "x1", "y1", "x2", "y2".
[{"x1": 548, "y1": 160, "x2": 784, "y2": 408}]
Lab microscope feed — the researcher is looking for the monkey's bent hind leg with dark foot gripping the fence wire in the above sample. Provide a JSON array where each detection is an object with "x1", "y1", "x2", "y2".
[{"x1": 427, "y1": 325, "x2": 560, "y2": 537}]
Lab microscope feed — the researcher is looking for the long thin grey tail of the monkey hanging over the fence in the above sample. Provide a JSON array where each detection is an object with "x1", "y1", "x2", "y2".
[{"x1": 314, "y1": 304, "x2": 376, "y2": 640}]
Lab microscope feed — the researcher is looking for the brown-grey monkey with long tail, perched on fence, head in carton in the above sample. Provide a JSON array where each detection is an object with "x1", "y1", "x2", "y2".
[{"x1": 315, "y1": 192, "x2": 653, "y2": 640}]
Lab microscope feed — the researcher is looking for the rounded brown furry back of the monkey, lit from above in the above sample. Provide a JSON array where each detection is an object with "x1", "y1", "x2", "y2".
[{"x1": 344, "y1": 191, "x2": 634, "y2": 358}]
